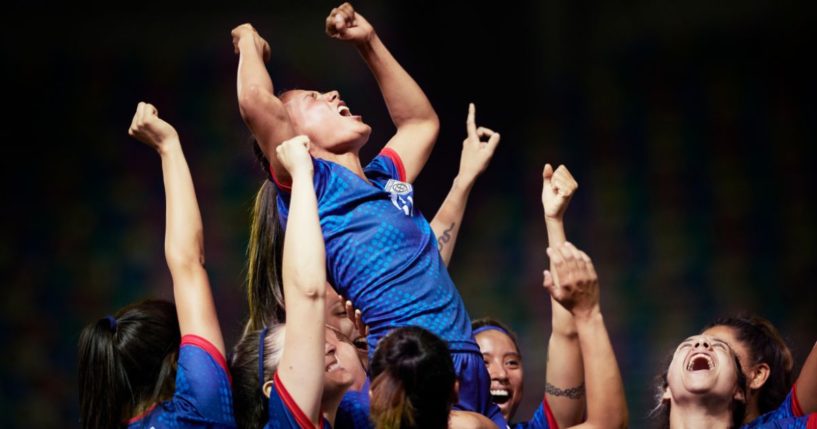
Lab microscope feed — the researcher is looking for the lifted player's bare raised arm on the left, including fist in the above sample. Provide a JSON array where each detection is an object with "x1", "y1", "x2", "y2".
[{"x1": 231, "y1": 24, "x2": 295, "y2": 183}]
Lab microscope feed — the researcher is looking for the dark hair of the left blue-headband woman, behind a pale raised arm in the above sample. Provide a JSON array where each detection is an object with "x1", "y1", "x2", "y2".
[{"x1": 230, "y1": 324, "x2": 284, "y2": 428}]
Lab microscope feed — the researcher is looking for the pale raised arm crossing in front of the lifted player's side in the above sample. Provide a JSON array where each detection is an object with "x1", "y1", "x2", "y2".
[{"x1": 277, "y1": 136, "x2": 326, "y2": 422}]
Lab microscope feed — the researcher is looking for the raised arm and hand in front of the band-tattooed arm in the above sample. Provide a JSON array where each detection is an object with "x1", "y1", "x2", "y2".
[{"x1": 544, "y1": 243, "x2": 627, "y2": 428}]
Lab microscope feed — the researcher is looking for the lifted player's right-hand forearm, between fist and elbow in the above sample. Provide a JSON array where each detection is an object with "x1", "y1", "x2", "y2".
[{"x1": 357, "y1": 33, "x2": 439, "y2": 130}]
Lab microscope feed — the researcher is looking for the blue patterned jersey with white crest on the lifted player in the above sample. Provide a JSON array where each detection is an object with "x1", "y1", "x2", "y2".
[{"x1": 270, "y1": 148, "x2": 478, "y2": 358}]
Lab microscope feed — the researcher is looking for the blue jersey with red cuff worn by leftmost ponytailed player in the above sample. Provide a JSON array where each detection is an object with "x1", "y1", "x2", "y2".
[{"x1": 128, "y1": 335, "x2": 236, "y2": 429}]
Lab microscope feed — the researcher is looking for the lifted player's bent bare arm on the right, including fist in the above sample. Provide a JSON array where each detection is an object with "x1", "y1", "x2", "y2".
[{"x1": 326, "y1": 3, "x2": 440, "y2": 182}]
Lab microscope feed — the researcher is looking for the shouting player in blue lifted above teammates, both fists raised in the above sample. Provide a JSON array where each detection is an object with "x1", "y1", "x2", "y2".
[{"x1": 232, "y1": 3, "x2": 505, "y2": 427}]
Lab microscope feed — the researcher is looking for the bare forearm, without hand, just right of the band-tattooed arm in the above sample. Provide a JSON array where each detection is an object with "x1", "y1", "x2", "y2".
[{"x1": 575, "y1": 308, "x2": 627, "y2": 428}]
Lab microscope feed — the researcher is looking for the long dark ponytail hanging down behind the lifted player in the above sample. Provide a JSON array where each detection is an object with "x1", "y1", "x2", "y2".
[{"x1": 245, "y1": 142, "x2": 286, "y2": 331}]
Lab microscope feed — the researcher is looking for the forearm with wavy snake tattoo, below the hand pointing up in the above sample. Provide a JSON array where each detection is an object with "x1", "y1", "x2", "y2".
[{"x1": 431, "y1": 176, "x2": 474, "y2": 266}]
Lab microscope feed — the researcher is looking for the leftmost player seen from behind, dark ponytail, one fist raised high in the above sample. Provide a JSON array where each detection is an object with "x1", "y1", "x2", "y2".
[{"x1": 79, "y1": 103, "x2": 235, "y2": 428}]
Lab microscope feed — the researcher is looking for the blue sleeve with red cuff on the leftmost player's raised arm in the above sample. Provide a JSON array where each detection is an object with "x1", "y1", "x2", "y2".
[{"x1": 173, "y1": 335, "x2": 235, "y2": 426}]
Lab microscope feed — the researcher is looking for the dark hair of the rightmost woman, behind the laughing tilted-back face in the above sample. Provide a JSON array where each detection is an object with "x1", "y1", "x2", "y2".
[{"x1": 704, "y1": 314, "x2": 794, "y2": 414}]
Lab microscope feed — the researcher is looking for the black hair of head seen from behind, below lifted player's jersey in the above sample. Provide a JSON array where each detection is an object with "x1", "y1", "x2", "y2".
[{"x1": 369, "y1": 326, "x2": 456, "y2": 429}]
